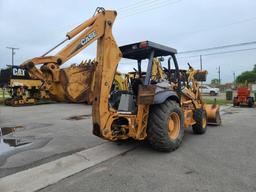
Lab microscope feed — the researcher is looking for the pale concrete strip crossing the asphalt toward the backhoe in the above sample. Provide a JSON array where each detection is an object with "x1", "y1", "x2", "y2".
[{"x1": 0, "y1": 143, "x2": 135, "y2": 192}]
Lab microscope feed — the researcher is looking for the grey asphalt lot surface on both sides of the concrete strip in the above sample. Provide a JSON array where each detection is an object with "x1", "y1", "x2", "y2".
[{"x1": 0, "y1": 104, "x2": 256, "y2": 192}]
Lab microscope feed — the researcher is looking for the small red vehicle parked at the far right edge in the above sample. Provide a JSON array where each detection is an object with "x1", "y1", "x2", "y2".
[{"x1": 233, "y1": 87, "x2": 254, "y2": 107}]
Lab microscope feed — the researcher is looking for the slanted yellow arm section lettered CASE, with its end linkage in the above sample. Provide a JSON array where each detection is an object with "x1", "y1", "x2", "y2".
[{"x1": 21, "y1": 9, "x2": 110, "y2": 81}]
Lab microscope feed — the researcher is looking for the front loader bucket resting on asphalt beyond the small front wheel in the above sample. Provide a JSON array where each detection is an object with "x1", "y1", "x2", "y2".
[{"x1": 204, "y1": 104, "x2": 221, "y2": 126}]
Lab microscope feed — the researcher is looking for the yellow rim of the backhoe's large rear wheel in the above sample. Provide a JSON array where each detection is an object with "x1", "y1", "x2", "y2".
[{"x1": 168, "y1": 112, "x2": 180, "y2": 140}]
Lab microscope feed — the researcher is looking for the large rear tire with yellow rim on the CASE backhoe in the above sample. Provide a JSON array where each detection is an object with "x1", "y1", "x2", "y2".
[{"x1": 147, "y1": 99, "x2": 184, "y2": 152}]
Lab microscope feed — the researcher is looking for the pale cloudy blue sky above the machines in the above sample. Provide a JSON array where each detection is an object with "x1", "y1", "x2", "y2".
[{"x1": 0, "y1": 0, "x2": 256, "y2": 82}]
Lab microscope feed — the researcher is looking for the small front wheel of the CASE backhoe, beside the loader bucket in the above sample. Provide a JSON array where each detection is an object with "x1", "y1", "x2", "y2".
[{"x1": 192, "y1": 109, "x2": 207, "y2": 135}]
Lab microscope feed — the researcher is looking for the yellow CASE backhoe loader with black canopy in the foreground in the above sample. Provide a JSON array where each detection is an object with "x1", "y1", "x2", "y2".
[{"x1": 23, "y1": 8, "x2": 219, "y2": 151}]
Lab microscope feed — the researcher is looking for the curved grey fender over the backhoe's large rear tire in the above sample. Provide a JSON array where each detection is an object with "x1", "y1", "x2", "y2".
[{"x1": 153, "y1": 90, "x2": 180, "y2": 104}]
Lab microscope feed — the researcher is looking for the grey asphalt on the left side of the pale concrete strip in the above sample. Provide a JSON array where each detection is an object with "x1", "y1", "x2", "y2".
[{"x1": 0, "y1": 103, "x2": 106, "y2": 178}]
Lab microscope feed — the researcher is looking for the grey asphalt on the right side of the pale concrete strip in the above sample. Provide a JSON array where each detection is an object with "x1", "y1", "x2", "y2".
[{"x1": 40, "y1": 108, "x2": 256, "y2": 192}]
